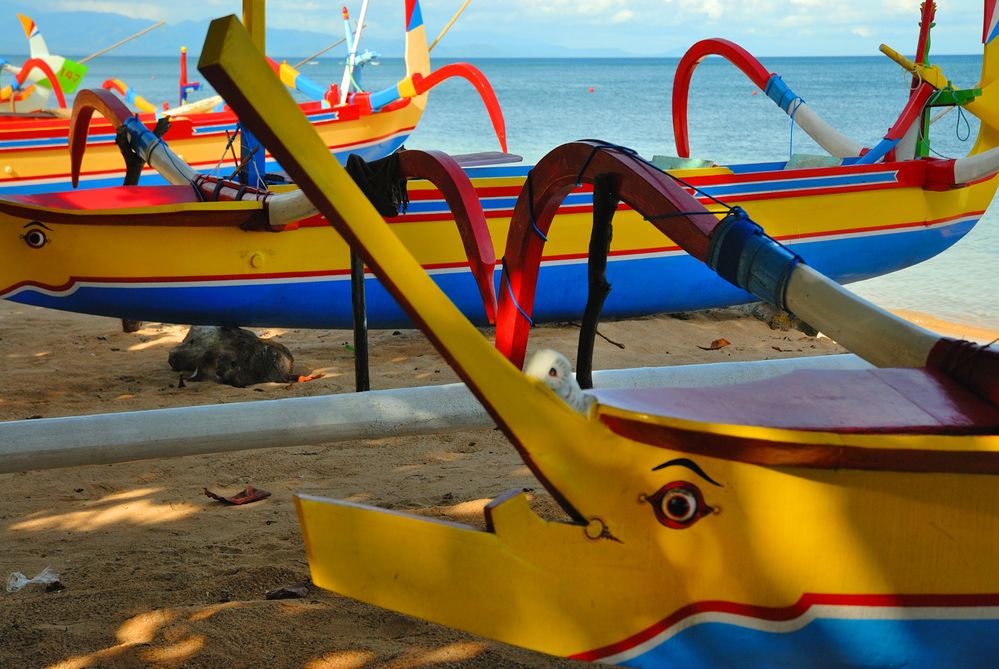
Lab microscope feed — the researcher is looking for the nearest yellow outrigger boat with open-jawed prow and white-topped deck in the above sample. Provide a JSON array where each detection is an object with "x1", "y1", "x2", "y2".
[{"x1": 201, "y1": 13, "x2": 999, "y2": 668}]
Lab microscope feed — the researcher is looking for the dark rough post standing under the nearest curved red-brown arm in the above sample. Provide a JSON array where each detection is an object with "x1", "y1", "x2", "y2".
[{"x1": 576, "y1": 174, "x2": 621, "y2": 388}]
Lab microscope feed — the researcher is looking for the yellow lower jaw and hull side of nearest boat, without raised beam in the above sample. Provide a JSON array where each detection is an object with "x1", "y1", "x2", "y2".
[{"x1": 296, "y1": 440, "x2": 999, "y2": 655}]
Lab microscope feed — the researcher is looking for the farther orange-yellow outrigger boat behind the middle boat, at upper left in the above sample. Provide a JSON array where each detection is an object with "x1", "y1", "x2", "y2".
[{"x1": 0, "y1": 0, "x2": 506, "y2": 195}]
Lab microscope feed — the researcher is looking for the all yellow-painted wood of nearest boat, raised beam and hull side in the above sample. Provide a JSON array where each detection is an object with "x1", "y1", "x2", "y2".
[{"x1": 201, "y1": 13, "x2": 999, "y2": 655}]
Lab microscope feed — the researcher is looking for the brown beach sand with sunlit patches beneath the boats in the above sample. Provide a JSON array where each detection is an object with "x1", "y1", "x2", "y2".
[{"x1": 0, "y1": 302, "x2": 995, "y2": 669}]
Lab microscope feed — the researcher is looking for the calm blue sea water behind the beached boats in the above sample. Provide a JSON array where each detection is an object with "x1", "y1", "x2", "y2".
[{"x1": 11, "y1": 56, "x2": 999, "y2": 328}]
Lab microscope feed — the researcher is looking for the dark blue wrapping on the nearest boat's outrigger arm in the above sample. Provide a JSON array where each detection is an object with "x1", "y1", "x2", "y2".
[{"x1": 708, "y1": 207, "x2": 803, "y2": 309}]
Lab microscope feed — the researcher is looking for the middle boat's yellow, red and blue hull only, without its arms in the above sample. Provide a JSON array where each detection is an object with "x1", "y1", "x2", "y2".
[{"x1": 0, "y1": 152, "x2": 999, "y2": 328}]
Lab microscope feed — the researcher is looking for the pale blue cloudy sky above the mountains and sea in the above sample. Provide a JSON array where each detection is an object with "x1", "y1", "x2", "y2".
[{"x1": 5, "y1": 0, "x2": 984, "y2": 57}]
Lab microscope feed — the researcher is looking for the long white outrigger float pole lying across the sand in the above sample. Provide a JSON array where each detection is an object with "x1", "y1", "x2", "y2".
[{"x1": 0, "y1": 355, "x2": 870, "y2": 474}]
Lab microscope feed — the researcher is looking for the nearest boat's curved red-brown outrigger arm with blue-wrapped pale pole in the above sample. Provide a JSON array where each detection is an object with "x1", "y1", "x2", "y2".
[{"x1": 496, "y1": 140, "x2": 999, "y2": 401}]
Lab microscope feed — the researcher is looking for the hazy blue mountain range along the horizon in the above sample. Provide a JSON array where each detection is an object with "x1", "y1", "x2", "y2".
[{"x1": 0, "y1": 0, "x2": 652, "y2": 60}]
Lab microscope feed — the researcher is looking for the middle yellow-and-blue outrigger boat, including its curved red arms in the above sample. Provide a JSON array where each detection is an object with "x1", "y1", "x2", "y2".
[{"x1": 0, "y1": 3, "x2": 999, "y2": 328}]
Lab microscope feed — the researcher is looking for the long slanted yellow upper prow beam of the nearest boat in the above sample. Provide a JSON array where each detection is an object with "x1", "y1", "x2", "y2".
[{"x1": 199, "y1": 17, "x2": 585, "y2": 494}]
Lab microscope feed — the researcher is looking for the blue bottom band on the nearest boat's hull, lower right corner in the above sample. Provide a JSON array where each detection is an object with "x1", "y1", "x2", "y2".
[{"x1": 621, "y1": 619, "x2": 999, "y2": 669}]
